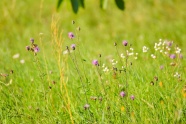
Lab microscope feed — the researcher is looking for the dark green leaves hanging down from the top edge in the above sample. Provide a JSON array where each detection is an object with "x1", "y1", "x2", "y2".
[{"x1": 57, "y1": 0, "x2": 125, "y2": 13}]
